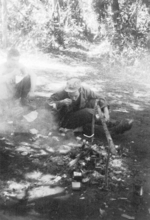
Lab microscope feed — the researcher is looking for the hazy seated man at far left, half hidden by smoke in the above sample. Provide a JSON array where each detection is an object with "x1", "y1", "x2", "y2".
[{"x1": 0, "y1": 49, "x2": 36, "y2": 110}]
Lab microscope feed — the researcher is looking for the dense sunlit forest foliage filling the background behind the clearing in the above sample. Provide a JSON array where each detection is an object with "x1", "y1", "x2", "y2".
[{"x1": 0, "y1": 0, "x2": 150, "y2": 63}]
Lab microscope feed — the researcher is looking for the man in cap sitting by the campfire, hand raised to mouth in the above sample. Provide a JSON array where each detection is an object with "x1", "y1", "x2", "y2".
[{"x1": 47, "y1": 78, "x2": 133, "y2": 136}]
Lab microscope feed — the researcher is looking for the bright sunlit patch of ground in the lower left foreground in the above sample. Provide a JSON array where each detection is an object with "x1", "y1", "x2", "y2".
[{"x1": 3, "y1": 172, "x2": 64, "y2": 201}]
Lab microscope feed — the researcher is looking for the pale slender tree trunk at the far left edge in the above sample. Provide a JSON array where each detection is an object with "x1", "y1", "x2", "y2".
[{"x1": 1, "y1": 0, "x2": 7, "y2": 49}]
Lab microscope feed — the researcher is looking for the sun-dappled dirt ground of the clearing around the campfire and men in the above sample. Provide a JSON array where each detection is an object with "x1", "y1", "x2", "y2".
[{"x1": 0, "y1": 48, "x2": 150, "y2": 220}]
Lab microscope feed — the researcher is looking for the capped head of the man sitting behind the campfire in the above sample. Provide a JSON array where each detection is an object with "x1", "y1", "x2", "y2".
[{"x1": 65, "y1": 78, "x2": 81, "y2": 101}]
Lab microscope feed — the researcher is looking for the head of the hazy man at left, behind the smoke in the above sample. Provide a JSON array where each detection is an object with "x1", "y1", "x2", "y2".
[{"x1": 7, "y1": 48, "x2": 20, "y2": 67}]
